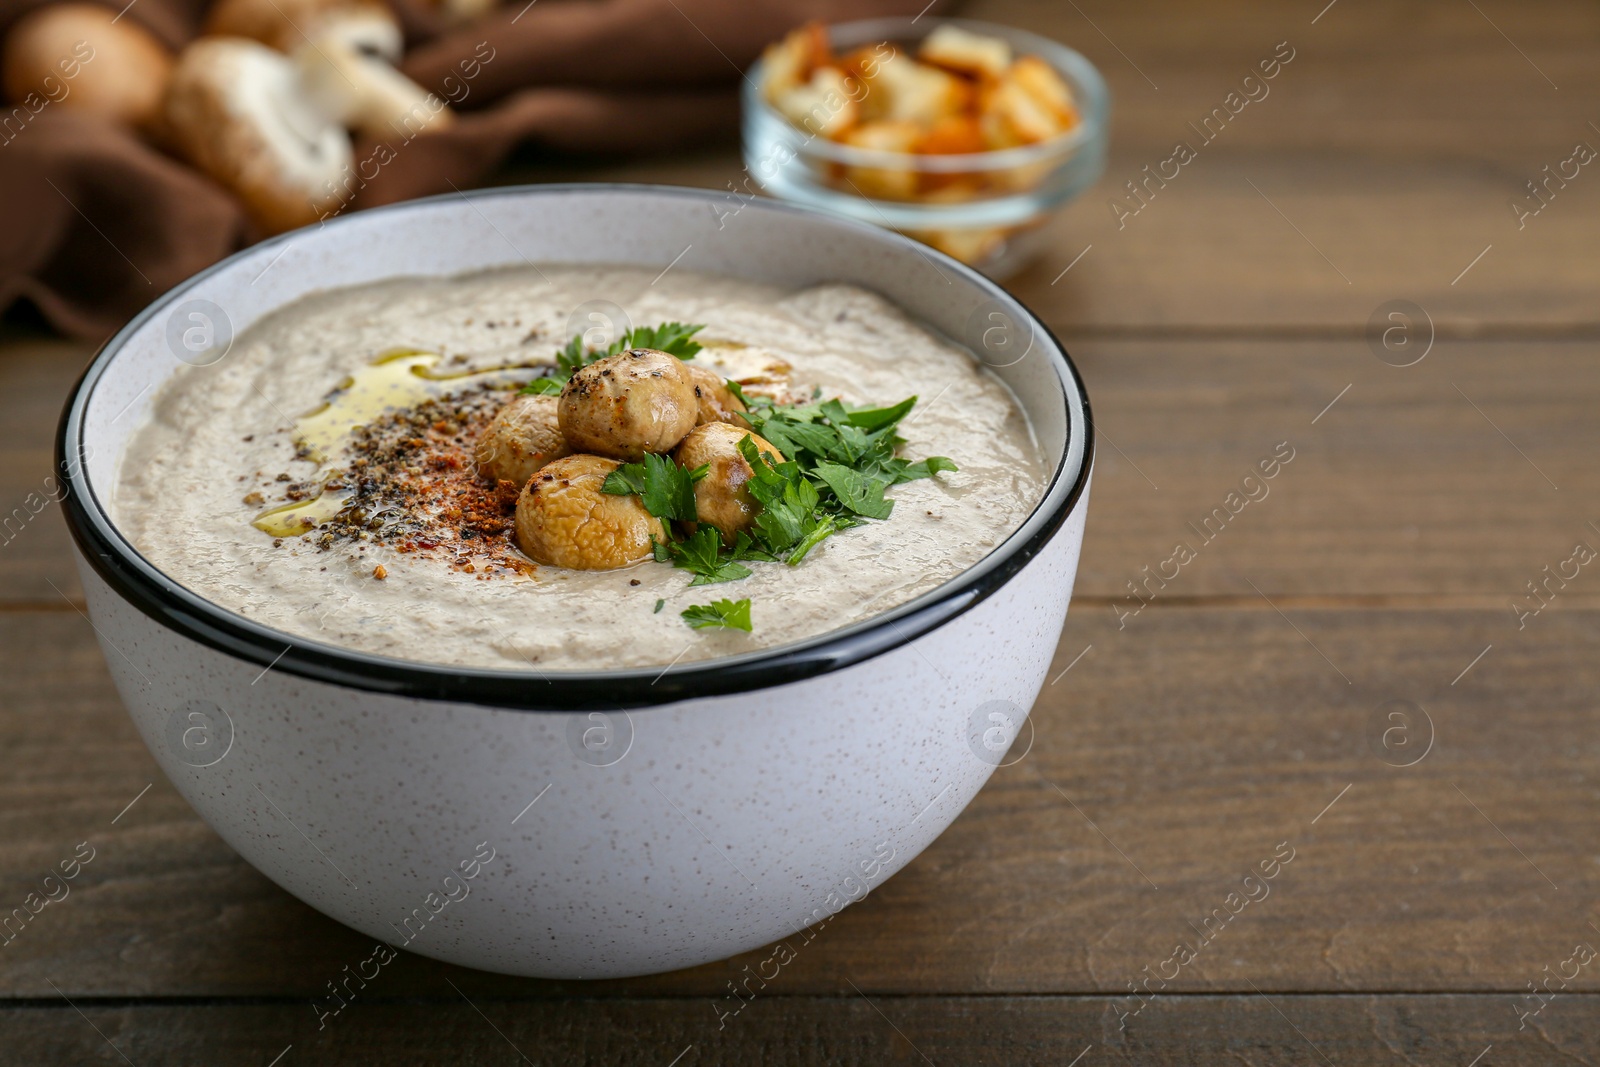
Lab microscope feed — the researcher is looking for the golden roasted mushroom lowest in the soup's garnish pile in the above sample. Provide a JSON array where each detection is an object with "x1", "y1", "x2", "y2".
[{"x1": 517, "y1": 456, "x2": 667, "y2": 571}]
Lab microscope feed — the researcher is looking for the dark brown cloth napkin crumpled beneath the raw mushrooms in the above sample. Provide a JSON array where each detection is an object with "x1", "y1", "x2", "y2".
[{"x1": 0, "y1": 0, "x2": 923, "y2": 339}]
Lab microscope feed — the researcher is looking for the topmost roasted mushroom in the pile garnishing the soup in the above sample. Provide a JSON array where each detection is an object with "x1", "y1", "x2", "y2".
[{"x1": 557, "y1": 349, "x2": 699, "y2": 459}]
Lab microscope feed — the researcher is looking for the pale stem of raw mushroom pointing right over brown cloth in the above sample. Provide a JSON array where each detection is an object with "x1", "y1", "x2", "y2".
[{"x1": 294, "y1": 32, "x2": 456, "y2": 141}]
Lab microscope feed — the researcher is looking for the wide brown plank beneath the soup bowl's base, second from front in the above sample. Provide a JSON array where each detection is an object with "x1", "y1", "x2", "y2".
[{"x1": 0, "y1": 606, "x2": 1600, "y2": 997}]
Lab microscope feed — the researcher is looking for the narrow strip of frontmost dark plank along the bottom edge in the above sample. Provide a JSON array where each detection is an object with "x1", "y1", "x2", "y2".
[{"x1": 0, "y1": 984, "x2": 1600, "y2": 1067}]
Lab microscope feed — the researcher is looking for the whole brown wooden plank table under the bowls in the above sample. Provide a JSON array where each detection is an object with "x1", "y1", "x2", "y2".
[{"x1": 0, "y1": 0, "x2": 1600, "y2": 1067}]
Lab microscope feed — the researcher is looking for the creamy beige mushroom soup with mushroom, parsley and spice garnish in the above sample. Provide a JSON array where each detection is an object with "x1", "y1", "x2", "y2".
[{"x1": 114, "y1": 266, "x2": 1048, "y2": 670}]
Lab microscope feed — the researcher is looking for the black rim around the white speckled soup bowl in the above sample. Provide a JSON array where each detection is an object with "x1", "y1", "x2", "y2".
[{"x1": 56, "y1": 182, "x2": 1094, "y2": 712}]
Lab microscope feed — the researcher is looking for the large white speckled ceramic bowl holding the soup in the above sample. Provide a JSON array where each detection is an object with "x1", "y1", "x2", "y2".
[{"x1": 59, "y1": 186, "x2": 1093, "y2": 979}]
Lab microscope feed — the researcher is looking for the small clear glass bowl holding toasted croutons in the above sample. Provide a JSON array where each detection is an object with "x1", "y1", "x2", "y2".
[{"x1": 736, "y1": 18, "x2": 1110, "y2": 278}]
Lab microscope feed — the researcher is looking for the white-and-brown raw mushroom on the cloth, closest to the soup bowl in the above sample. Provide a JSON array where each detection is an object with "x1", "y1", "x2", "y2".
[{"x1": 165, "y1": 37, "x2": 352, "y2": 234}]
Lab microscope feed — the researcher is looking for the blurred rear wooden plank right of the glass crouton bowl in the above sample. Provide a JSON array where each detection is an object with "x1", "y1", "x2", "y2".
[{"x1": 963, "y1": 0, "x2": 1600, "y2": 329}]
